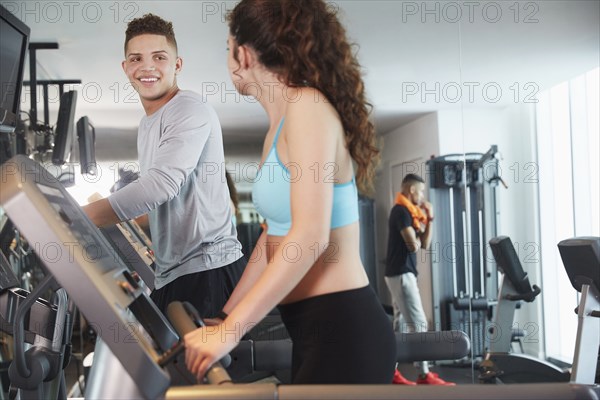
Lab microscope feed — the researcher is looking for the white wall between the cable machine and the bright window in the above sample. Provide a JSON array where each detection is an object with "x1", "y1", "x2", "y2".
[{"x1": 438, "y1": 104, "x2": 543, "y2": 356}]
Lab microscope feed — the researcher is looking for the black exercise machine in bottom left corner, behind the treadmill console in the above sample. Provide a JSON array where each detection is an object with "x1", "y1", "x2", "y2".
[{"x1": 0, "y1": 252, "x2": 73, "y2": 400}]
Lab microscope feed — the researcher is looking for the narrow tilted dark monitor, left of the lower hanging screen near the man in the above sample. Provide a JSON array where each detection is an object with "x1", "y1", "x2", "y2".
[{"x1": 52, "y1": 90, "x2": 77, "y2": 165}]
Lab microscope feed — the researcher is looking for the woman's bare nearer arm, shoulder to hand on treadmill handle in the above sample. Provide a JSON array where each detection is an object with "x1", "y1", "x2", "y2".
[{"x1": 185, "y1": 94, "x2": 342, "y2": 378}]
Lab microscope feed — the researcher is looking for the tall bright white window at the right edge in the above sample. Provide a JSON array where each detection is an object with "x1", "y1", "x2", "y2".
[{"x1": 536, "y1": 68, "x2": 600, "y2": 363}]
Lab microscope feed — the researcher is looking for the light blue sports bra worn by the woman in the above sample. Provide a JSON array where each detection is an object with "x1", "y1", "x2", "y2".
[{"x1": 252, "y1": 119, "x2": 358, "y2": 236}]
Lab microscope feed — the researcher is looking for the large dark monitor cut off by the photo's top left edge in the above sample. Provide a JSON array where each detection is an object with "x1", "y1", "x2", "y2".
[{"x1": 0, "y1": 5, "x2": 30, "y2": 132}]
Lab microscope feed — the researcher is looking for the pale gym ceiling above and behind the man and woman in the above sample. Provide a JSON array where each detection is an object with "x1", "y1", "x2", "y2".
[{"x1": 0, "y1": 0, "x2": 600, "y2": 159}]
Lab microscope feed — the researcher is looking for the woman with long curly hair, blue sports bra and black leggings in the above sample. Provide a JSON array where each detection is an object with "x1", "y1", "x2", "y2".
[{"x1": 185, "y1": 0, "x2": 396, "y2": 384}]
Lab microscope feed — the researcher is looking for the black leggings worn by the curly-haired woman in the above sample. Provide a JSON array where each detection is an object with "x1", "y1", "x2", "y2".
[{"x1": 279, "y1": 286, "x2": 396, "y2": 384}]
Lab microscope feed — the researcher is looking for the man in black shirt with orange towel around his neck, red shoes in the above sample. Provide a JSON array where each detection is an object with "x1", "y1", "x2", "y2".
[{"x1": 385, "y1": 174, "x2": 453, "y2": 385}]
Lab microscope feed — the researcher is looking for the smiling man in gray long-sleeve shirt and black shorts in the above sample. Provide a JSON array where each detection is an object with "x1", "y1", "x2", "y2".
[{"x1": 84, "y1": 14, "x2": 245, "y2": 317}]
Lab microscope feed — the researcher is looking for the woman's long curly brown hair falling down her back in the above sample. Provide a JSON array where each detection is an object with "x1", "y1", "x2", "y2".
[{"x1": 227, "y1": 0, "x2": 379, "y2": 193}]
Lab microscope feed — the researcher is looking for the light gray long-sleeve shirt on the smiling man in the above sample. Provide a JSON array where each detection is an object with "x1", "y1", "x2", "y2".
[{"x1": 108, "y1": 91, "x2": 242, "y2": 289}]
